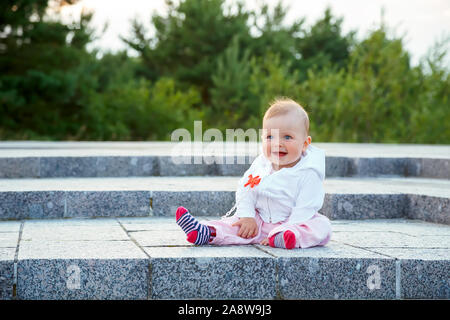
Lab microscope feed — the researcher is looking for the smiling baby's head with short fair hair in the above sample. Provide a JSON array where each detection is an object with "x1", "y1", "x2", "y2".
[{"x1": 262, "y1": 98, "x2": 311, "y2": 170}]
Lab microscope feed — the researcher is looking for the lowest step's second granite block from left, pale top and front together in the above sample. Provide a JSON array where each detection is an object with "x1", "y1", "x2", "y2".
[{"x1": 17, "y1": 240, "x2": 149, "y2": 300}]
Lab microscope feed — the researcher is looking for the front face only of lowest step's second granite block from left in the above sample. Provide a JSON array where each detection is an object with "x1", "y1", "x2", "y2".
[{"x1": 17, "y1": 258, "x2": 149, "y2": 300}]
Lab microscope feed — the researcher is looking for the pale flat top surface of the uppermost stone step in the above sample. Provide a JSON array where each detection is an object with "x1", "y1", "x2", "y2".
[{"x1": 0, "y1": 141, "x2": 450, "y2": 159}]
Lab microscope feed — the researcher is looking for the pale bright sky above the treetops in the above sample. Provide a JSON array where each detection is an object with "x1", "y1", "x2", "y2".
[{"x1": 62, "y1": 0, "x2": 450, "y2": 64}]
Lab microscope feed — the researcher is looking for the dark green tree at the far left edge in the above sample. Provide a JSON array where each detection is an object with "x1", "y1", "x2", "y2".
[{"x1": 0, "y1": 0, "x2": 93, "y2": 139}]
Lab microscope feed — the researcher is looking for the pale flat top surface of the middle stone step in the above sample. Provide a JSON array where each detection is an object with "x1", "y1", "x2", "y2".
[{"x1": 0, "y1": 177, "x2": 450, "y2": 198}]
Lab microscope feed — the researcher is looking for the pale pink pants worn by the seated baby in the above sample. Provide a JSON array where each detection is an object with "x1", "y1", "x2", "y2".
[{"x1": 202, "y1": 213, "x2": 331, "y2": 248}]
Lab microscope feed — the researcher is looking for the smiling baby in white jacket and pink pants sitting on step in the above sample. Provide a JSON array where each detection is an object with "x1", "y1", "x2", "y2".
[{"x1": 176, "y1": 99, "x2": 331, "y2": 249}]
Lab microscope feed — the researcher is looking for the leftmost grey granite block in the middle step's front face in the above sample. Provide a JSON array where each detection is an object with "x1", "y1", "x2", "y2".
[{"x1": 0, "y1": 191, "x2": 65, "y2": 219}]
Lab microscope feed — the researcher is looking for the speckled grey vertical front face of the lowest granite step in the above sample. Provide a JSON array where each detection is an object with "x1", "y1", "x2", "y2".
[{"x1": 0, "y1": 246, "x2": 450, "y2": 300}]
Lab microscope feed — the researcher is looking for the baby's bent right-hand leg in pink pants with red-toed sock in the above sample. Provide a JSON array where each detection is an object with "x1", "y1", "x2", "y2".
[{"x1": 269, "y1": 213, "x2": 331, "y2": 249}]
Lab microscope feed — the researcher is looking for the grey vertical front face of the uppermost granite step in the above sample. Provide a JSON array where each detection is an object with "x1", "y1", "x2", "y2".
[{"x1": 0, "y1": 156, "x2": 450, "y2": 179}]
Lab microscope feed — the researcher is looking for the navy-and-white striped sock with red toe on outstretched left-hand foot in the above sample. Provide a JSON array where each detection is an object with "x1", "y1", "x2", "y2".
[{"x1": 176, "y1": 207, "x2": 211, "y2": 245}]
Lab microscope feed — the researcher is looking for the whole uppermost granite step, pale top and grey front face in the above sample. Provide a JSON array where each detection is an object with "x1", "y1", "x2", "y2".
[{"x1": 0, "y1": 141, "x2": 450, "y2": 179}]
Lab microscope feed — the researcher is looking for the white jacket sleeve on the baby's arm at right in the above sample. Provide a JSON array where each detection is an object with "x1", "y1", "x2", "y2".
[{"x1": 286, "y1": 170, "x2": 325, "y2": 224}]
